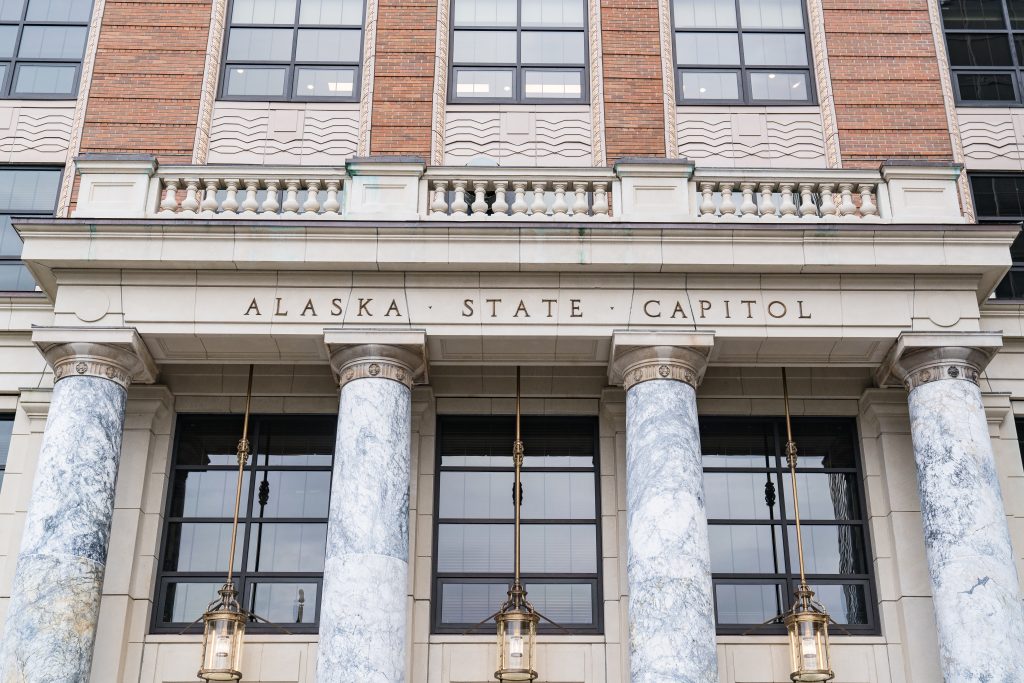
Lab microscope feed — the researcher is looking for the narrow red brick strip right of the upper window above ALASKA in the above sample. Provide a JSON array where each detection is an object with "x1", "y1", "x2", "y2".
[{"x1": 370, "y1": 0, "x2": 436, "y2": 160}]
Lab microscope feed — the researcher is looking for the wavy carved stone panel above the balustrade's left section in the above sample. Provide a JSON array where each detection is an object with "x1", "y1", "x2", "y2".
[{"x1": 208, "y1": 102, "x2": 359, "y2": 166}]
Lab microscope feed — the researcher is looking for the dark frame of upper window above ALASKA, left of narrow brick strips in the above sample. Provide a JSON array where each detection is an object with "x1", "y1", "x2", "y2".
[{"x1": 217, "y1": 0, "x2": 367, "y2": 102}]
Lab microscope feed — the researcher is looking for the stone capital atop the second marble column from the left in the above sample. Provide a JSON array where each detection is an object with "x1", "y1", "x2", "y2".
[{"x1": 324, "y1": 330, "x2": 427, "y2": 388}]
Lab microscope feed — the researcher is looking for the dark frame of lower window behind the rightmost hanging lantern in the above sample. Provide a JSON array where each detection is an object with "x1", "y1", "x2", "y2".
[{"x1": 699, "y1": 416, "x2": 881, "y2": 636}]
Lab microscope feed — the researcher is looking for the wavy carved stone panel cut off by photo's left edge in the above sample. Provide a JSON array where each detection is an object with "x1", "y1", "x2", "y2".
[{"x1": 0, "y1": 100, "x2": 75, "y2": 165}]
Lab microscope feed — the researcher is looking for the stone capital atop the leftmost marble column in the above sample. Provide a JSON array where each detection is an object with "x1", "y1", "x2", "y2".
[{"x1": 32, "y1": 327, "x2": 159, "y2": 388}]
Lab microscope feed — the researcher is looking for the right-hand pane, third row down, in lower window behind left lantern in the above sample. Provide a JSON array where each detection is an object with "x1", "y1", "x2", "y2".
[{"x1": 247, "y1": 524, "x2": 327, "y2": 572}]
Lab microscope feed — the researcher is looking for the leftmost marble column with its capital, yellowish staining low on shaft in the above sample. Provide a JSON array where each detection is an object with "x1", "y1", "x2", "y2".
[{"x1": 0, "y1": 328, "x2": 154, "y2": 683}]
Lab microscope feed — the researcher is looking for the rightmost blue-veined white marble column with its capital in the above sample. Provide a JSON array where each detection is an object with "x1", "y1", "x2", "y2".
[{"x1": 893, "y1": 334, "x2": 1024, "y2": 683}]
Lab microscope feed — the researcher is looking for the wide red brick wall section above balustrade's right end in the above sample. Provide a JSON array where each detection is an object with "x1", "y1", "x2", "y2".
[{"x1": 823, "y1": 0, "x2": 952, "y2": 168}]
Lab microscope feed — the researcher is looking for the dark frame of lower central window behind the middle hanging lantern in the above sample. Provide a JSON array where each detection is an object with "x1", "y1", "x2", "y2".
[{"x1": 430, "y1": 415, "x2": 604, "y2": 635}]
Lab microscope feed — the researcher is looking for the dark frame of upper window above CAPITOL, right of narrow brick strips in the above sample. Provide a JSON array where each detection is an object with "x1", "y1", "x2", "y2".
[{"x1": 669, "y1": 0, "x2": 818, "y2": 106}]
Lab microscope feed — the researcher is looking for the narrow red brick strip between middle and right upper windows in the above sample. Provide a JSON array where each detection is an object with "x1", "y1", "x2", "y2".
[{"x1": 601, "y1": 0, "x2": 666, "y2": 164}]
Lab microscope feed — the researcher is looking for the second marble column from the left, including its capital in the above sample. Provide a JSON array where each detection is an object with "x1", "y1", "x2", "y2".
[{"x1": 316, "y1": 333, "x2": 423, "y2": 683}]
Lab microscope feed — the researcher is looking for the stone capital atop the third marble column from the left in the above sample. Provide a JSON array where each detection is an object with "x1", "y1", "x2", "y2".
[{"x1": 608, "y1": 332, "x2": 715, "y2": 391}]
